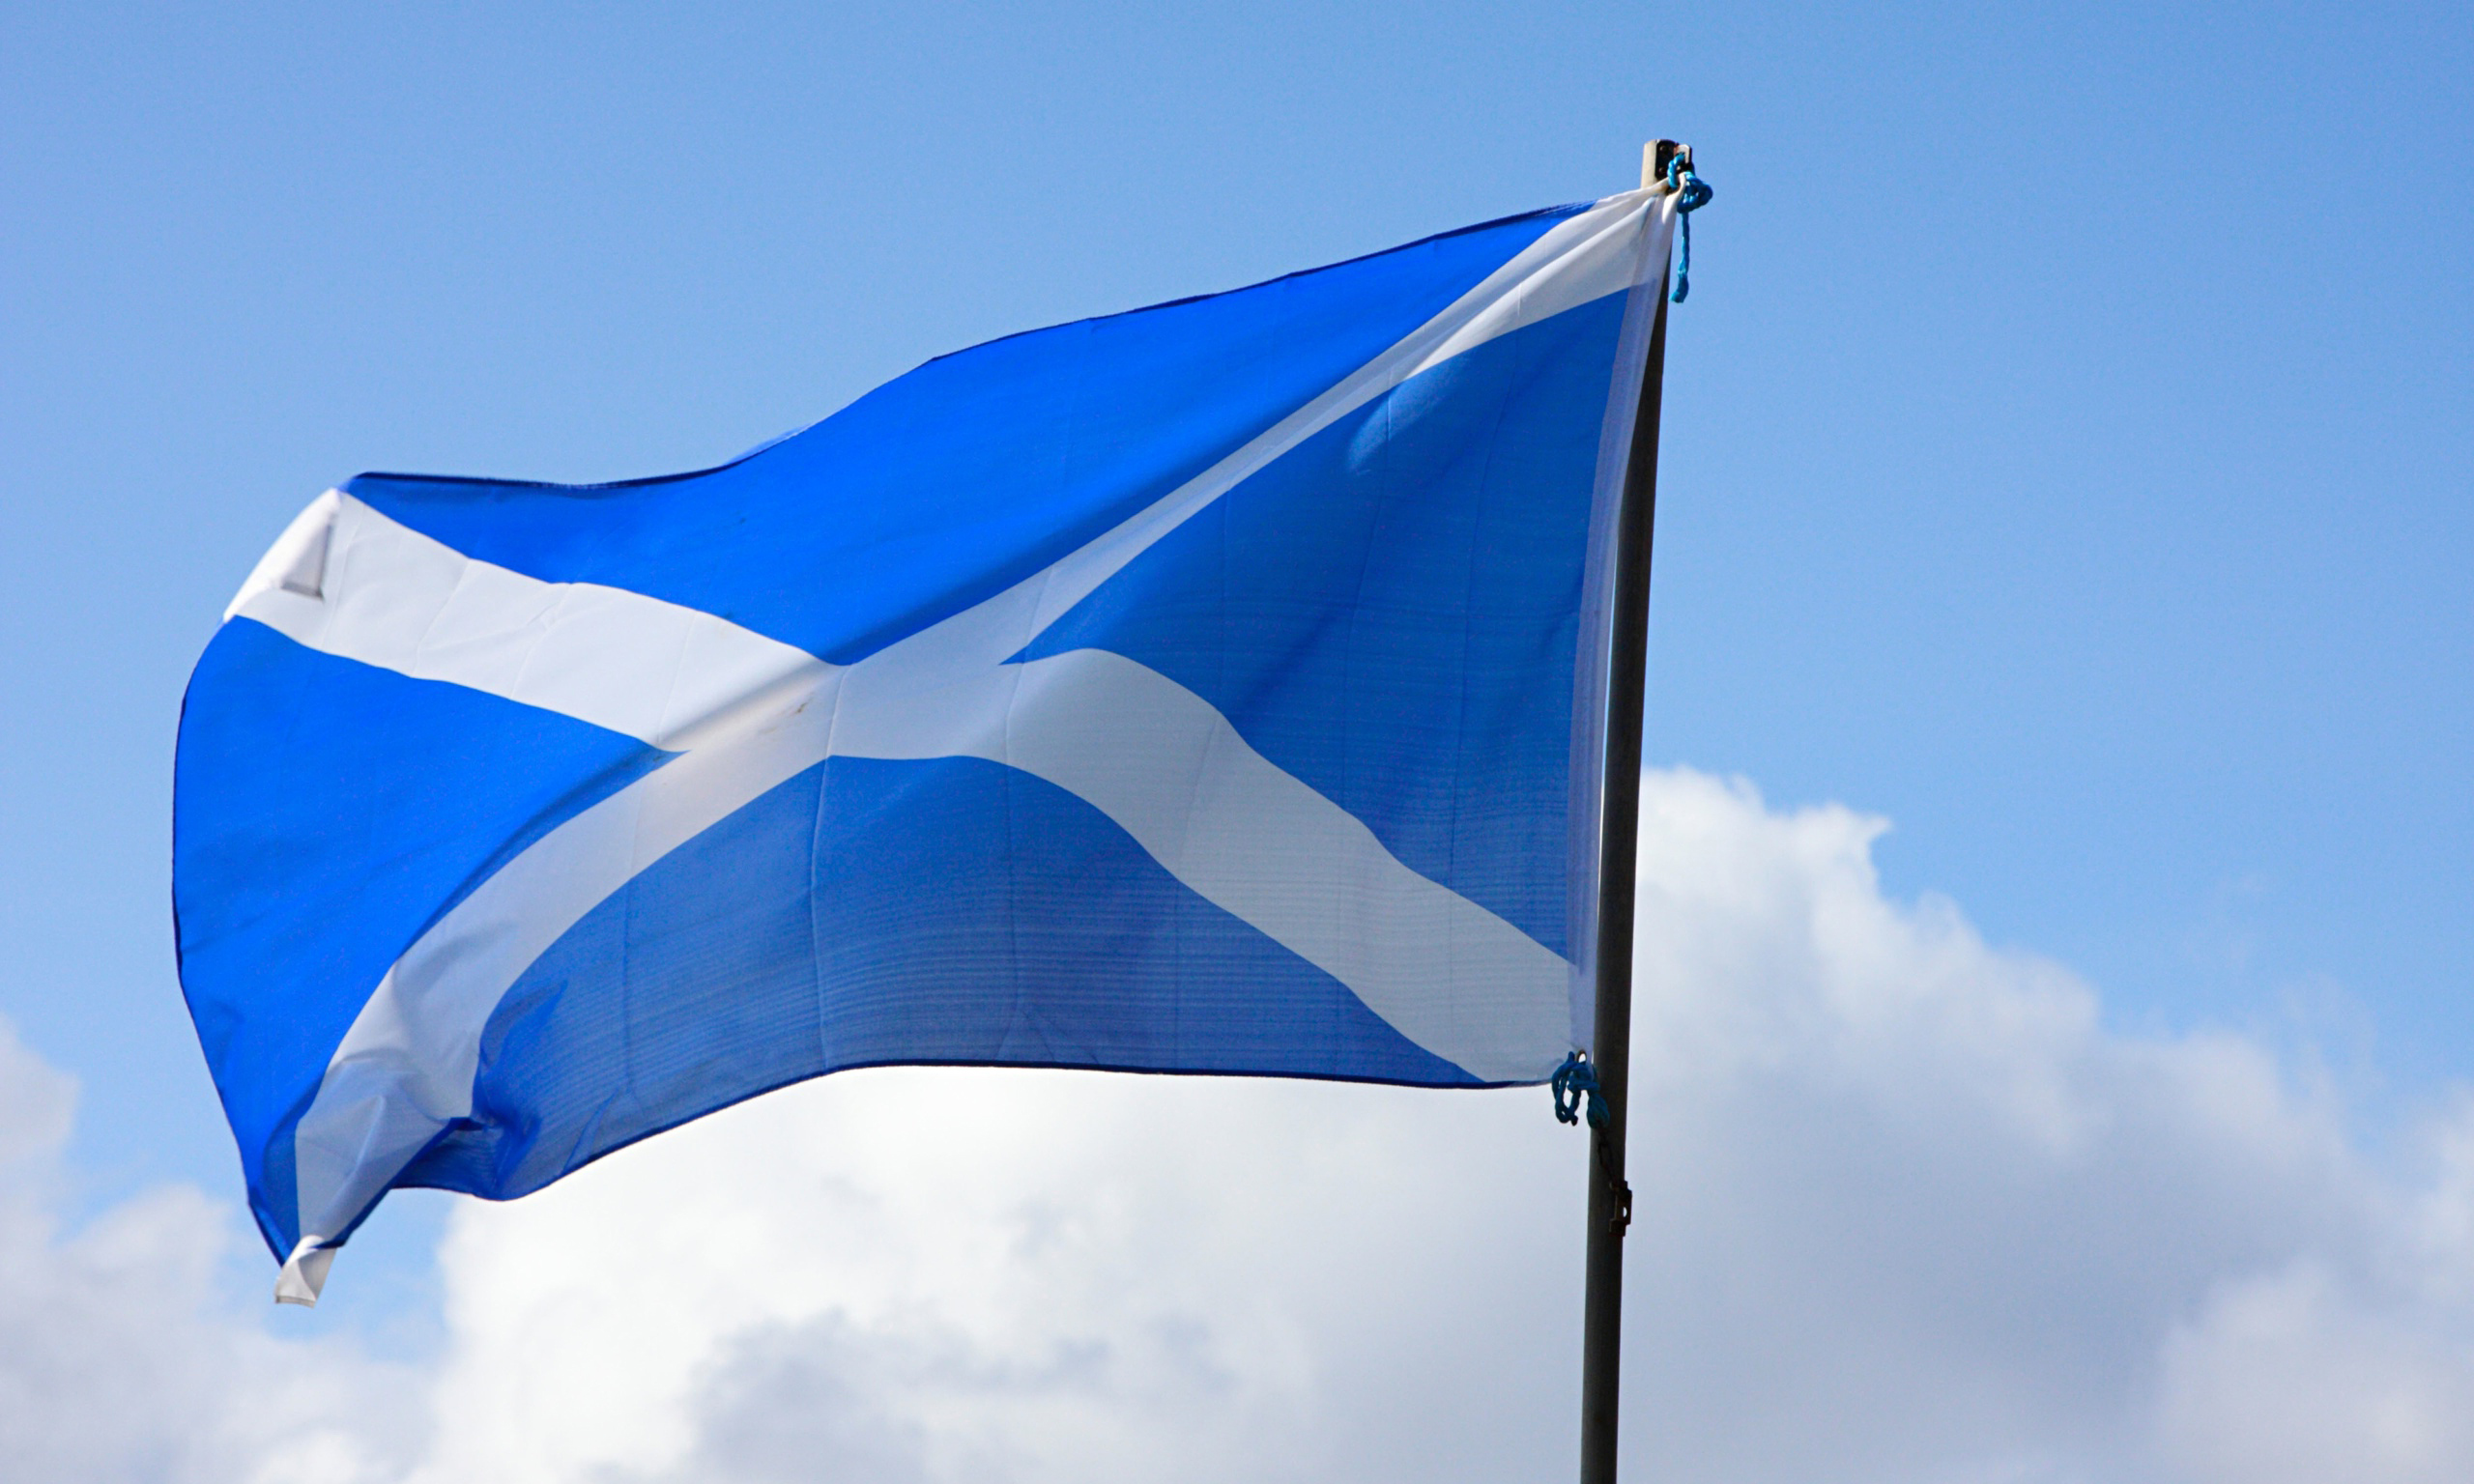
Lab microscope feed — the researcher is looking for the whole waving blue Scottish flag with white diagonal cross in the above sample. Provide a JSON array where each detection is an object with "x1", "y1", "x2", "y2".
[{"x1": 173, "y1": 193, "x2": 1675, "y2": 1301}]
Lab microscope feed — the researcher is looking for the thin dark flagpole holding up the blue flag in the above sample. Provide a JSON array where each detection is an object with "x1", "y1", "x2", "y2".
[{"x1": 1581, "y1": 153, "x2": 1675, "y2": 1484}]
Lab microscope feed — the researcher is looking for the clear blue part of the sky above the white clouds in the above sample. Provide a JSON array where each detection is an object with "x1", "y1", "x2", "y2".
[{"x1": 0, "y1": 5, "x2": 2474, "y2": 1444}]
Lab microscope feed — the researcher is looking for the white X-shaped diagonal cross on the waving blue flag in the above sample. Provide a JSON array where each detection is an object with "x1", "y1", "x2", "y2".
[{"x1": 250, "y1": 193, "x2": 1673, "y2": 1296}]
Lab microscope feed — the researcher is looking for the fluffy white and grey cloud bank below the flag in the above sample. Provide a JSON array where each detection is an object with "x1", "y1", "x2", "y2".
[{"x1": 14, "y1": 769, "x2": 2474, "y2": 1484}]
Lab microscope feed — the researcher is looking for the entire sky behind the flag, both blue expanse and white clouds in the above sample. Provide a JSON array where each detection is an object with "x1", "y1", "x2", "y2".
[{"x1": 0, "y1": 3, "x2": 2474, "y2": 1481}]
